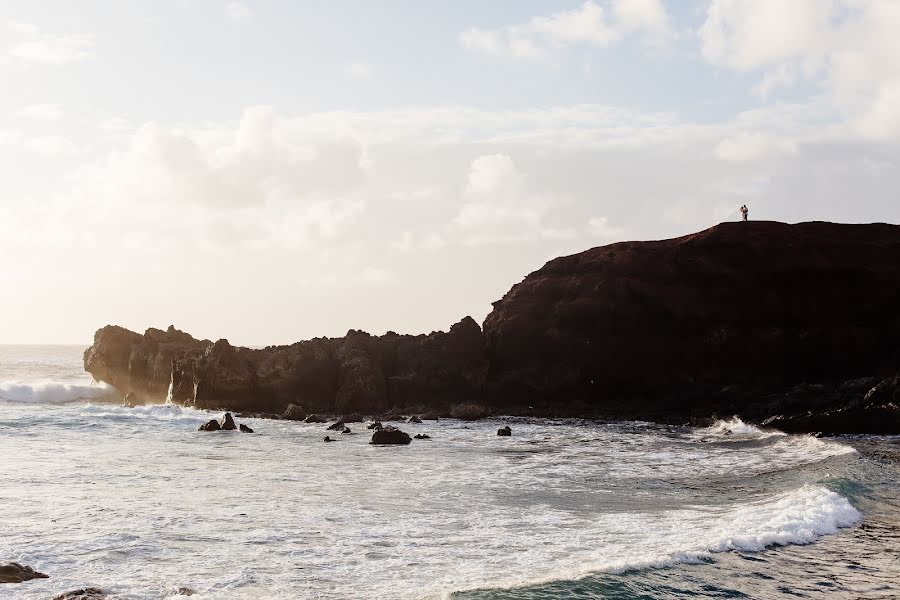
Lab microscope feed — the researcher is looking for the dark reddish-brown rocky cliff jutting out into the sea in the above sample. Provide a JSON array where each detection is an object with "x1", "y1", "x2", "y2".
[{"x1": 85, "y1": 222, "x2": 900, "y2": 432}]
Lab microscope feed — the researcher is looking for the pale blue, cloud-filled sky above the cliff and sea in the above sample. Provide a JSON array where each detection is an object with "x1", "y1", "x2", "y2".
[{"x1": 0, "y1": 0, "x2": 900, "y2": 345}]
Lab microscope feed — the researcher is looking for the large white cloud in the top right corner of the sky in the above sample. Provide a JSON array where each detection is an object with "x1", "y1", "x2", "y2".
[{"x1": 699, "y1": 0, "x2": 900, "y2": 140}]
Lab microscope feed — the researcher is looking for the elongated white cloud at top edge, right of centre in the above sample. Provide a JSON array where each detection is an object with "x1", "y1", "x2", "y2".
[{"x1": 459, "y1": 0, "x2": 669, "y2": 60}]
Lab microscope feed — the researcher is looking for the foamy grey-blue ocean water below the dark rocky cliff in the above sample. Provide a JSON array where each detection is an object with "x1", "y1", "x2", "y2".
[{"x1": 0, "y1": 346, "x2": 900, "y2": 600}]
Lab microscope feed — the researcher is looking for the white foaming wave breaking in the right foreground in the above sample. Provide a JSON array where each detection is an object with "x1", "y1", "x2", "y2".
[{"x1": 454, "y1": 485, "x2": 862, "y2": 598}]
